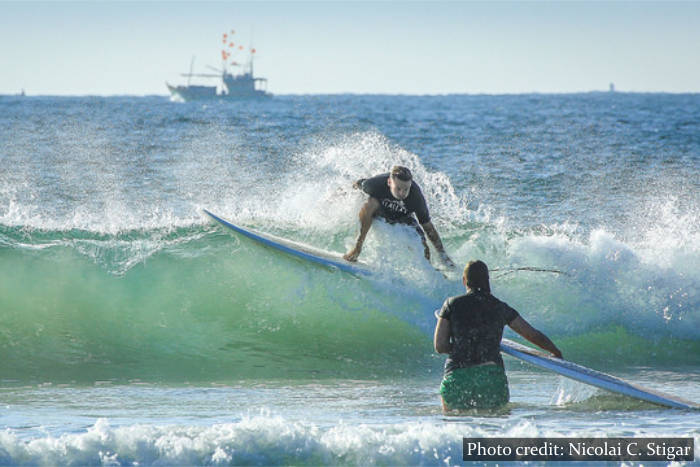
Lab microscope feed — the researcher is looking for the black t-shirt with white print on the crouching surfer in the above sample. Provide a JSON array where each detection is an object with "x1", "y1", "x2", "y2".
[{"x1": 358, "y1": 173, "x2": 430, "y2": 224}]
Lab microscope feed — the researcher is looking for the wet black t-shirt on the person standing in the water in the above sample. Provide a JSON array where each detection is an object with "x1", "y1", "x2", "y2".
[{"x1": 438, "y1": 291, "x2": 520, "y2": 375}]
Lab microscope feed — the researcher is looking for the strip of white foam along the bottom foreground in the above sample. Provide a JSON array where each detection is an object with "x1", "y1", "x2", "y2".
[{"x1": 0, "y1": 414, "x2": 700, "y2": 466}]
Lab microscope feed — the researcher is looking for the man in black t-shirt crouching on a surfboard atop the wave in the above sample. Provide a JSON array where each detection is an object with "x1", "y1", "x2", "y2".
[{"x1": 343, "y1": 165, "x2": 455, "y2": 268}]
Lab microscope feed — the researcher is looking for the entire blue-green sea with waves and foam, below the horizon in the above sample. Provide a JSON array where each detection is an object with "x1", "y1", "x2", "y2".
[{"x1": 0, "y1": 93, "x2": 700, "y2": 466}]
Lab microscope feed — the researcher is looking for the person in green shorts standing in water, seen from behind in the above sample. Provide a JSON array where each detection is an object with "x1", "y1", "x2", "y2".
[{"x1": 433, "y1": 261, "x2": 562, "y2": 411}]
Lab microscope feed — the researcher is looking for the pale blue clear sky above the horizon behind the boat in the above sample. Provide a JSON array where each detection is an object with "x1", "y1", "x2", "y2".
[{"x1": 0, "y1": 0, "x2": 700, "y2": 95}]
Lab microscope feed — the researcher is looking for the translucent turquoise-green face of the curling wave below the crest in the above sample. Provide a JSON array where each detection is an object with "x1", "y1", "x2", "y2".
[{"x1": 0, "y1": 226, "x2": 700, "y2": 384}]
